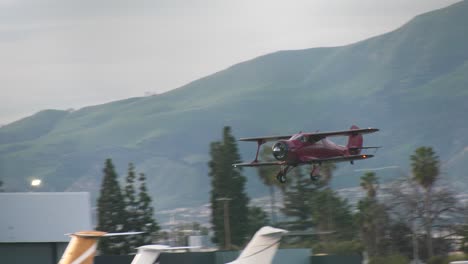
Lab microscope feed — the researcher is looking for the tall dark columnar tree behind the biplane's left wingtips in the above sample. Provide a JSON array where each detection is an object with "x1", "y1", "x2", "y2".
[{"x1": 208, "y1": 127, "x2": 249, "y2": 248}]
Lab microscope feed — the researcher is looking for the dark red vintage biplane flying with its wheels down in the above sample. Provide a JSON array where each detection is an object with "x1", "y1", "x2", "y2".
[{"x1": 233, "y1": 125, "x2": 379, "y2": 183}]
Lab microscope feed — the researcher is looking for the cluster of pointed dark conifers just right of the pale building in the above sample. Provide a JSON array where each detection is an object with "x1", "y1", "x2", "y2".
[{"x1": 96, "y1": 159, "x2": 160, "y2": 255}]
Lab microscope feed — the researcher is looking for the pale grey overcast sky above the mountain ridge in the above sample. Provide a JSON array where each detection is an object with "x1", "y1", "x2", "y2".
[{"x1": 0, "y1": 0, "x2": 458, "y2": 124}]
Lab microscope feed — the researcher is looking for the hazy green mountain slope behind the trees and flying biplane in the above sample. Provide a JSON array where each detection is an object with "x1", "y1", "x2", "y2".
[{"x1": 0, "y1": 0, "x2": 468, "y2": 213}]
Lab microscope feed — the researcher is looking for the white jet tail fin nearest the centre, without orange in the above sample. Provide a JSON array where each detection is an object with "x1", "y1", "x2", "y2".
[{"x1": 229, "y1": 226, "x2": 287, "y2": 264}]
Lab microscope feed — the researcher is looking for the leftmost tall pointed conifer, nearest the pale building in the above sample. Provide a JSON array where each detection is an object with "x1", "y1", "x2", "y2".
[{"x1": 96, "y1": 159, "x2": 128, "y2": 255}]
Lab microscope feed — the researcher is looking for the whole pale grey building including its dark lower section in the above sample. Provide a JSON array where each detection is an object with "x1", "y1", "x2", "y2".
[{"x1": 0, "y1": 192, "x2": 92, "y2": 264}]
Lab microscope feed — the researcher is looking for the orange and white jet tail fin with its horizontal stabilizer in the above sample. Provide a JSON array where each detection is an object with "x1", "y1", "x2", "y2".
[{"x1": 59, "y1": 231, "x2": 143, "y2": 264}]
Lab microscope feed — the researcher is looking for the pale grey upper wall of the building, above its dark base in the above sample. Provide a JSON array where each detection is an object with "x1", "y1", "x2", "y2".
[{"x1": 0, "y1": 192, "x2": 92, "y2": 243}]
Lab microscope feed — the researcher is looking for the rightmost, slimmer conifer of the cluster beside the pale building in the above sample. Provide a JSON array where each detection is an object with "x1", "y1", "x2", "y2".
[{"x1": 135, "y1": 173, "x2": 160, "y2": 247}]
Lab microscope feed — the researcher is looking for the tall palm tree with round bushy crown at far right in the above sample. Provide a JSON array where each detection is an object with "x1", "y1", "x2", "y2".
[{"x1": 410, "y1": 147, "x2": 439, "y2": 258}]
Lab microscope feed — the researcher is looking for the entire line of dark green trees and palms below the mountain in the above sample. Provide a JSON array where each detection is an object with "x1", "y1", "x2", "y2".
[{"x1": 98, "y1": 127, "x2": 468, "y2": 264}]
